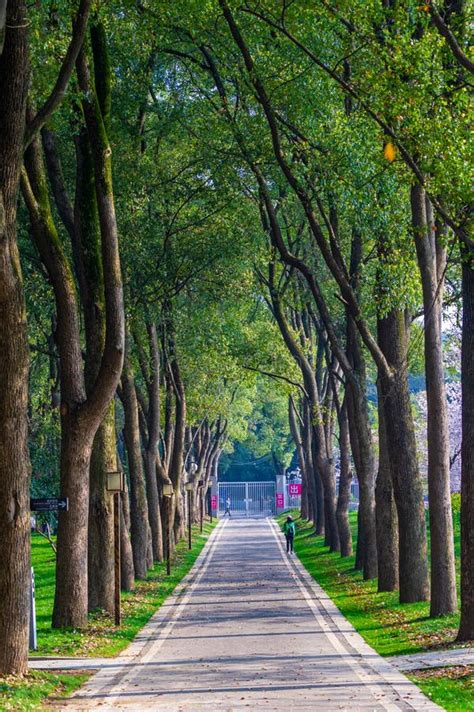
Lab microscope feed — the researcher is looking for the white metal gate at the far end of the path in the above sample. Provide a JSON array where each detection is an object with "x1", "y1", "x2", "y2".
[{"x1": 218, "y1": 482, "x2": 276, "y2": 517}]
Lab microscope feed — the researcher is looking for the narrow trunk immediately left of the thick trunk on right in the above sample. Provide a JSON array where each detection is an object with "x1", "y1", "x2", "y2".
[{"x1": 375, "y1": 385, "x2": 399, "y2": 591}]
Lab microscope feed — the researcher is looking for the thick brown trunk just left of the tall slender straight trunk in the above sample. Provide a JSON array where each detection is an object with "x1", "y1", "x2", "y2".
[{"x1": 378, "y1": 311, "x2": 429, "y2": 603}]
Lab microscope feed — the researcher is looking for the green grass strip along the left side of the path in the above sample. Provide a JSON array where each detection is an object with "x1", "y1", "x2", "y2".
[{"x1": 0, "y1": 520, "x2": 217, "y2": 710}]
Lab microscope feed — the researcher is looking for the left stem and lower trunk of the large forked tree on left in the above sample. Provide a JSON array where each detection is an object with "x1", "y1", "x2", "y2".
[{"x1": 22, "y1": 138, "x2": 91, "y2": 628}]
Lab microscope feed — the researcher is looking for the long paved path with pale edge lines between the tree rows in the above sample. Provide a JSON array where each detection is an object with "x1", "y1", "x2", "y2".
[{"x1": 57, "y1": 519, "x2": 440, "y2": 712}]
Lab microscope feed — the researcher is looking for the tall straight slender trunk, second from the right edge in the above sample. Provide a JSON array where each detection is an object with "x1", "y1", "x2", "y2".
[{"x1": 411, "y1": 183, "x2": 457, "y2": 616}]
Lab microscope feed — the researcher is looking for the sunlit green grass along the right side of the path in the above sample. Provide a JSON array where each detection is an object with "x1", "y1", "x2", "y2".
[{"x1": 278, "y1": 511, "x2": 474, "y2": 710}]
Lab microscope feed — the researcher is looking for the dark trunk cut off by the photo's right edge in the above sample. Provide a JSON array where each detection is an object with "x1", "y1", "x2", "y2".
[{"x1": 458, "y1": 247, "x2": 474, "y2": 640}]
